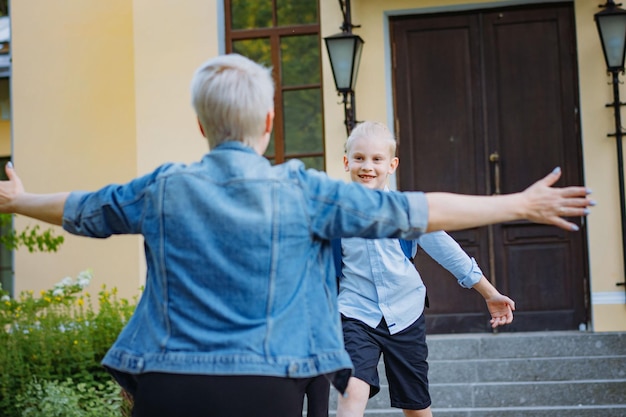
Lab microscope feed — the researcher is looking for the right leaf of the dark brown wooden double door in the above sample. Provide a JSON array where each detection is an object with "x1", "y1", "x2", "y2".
[{"x1": 482, "y1": 5, "x2": 587, "y2": 330}]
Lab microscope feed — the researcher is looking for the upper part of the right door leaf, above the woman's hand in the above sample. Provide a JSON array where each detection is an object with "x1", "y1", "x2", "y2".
[{"x1": 482, "y1": 7, "x2": 580, "y2": 193}]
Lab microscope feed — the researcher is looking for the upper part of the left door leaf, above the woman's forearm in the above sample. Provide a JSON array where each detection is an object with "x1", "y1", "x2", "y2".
[{"x1": 396, "y1": 12, "x2": 485, "y2": 194}]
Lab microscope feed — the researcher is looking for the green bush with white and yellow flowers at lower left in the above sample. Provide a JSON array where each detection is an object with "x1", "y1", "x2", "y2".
[{"x1": 0, "y1": 271, "x2": 136, "y2": 417}]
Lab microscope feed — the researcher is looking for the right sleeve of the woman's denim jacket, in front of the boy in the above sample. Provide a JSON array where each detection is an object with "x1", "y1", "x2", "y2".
[{"x1": 292, "y1": 163, "x2": 428, "y2": 239}]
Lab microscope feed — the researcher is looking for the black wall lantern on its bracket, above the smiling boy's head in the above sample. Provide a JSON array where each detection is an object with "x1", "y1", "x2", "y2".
[{"x1": 324, "y1": 0, "x2": 364, "y2": 135}]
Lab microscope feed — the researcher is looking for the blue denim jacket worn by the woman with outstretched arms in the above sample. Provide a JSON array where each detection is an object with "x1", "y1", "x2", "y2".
[{"x1": 63, "y1": 142, "x2": 428, "y2": 391}]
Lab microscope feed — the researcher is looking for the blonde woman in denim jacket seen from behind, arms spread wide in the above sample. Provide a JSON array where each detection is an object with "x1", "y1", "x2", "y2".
[{"x1": 0, "y1": 54, "x2": 593, "y2": 417}]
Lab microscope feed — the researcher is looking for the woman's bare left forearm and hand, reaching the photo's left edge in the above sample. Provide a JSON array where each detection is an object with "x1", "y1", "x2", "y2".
[{"x1": 0, "y1": 162, "x2": 69, "y2": 226}]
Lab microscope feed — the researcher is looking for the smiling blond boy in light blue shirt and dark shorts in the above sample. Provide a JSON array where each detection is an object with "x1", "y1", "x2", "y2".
[{"x1": 337, "y1": 122, "x2": 515, "y2": 417}]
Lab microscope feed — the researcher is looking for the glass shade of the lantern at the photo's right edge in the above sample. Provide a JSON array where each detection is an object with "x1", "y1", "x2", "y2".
[{"x1": 595, "y1": 6, "x2": 626, "y2": 70}]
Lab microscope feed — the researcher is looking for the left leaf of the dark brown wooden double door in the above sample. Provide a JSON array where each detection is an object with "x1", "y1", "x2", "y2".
[{"x1": 393, "y1": 11, "x2": 489, "y2": 333}]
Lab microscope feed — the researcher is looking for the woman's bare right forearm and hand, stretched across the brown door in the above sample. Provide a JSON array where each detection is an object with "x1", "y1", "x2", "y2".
[{"x1": 426, "y1": 168, "x2": 595, "y2": 232}]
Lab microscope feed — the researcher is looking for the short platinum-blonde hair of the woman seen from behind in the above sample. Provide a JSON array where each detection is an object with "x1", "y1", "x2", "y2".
[{"x1": 191, "y1": 54, "x2": 274, "y2": 149}]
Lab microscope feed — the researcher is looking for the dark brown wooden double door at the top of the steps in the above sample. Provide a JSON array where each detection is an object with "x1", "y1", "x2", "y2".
[{"x1": 391, "y1": 4, "x2": 588, "y2": 333}]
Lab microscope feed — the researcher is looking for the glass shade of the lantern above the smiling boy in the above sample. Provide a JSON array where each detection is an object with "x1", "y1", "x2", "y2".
[{"x1": 324, "y1": 33, "x2": 364, "y2": 92}]
